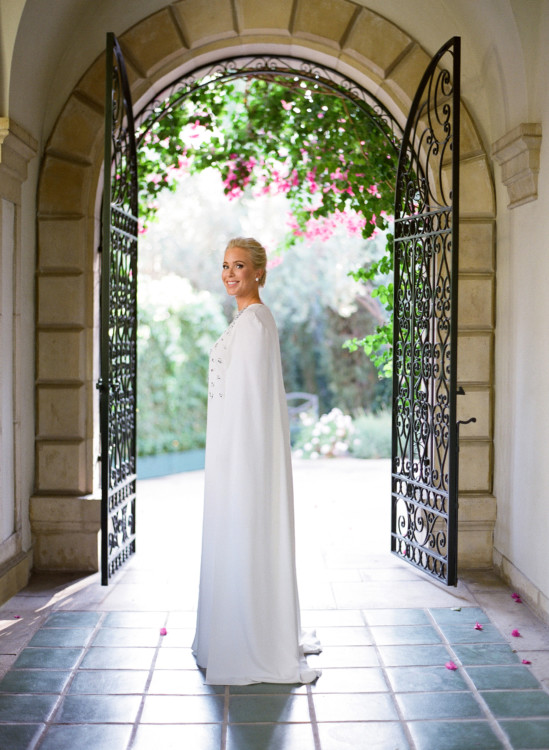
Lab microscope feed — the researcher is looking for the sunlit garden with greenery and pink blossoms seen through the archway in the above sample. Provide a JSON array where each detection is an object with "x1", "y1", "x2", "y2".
[{"x1": 138, "y1": 80, "x2": 395, "y2": 476}]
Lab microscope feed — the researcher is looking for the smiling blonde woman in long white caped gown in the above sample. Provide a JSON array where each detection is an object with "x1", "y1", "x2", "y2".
[{"x1": 193, "y1": 237, "x2": 320, "y2": 685}]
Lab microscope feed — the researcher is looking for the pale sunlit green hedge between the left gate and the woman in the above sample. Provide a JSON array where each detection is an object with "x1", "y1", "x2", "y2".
[{"x1": 137, "y1": 276, "x2": 226, "y2": 456}]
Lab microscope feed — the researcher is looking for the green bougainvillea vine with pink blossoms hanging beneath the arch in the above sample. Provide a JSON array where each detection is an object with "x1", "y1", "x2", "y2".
[{"x1": 138, "y1": 77, "x2": 396, "y2": 377}]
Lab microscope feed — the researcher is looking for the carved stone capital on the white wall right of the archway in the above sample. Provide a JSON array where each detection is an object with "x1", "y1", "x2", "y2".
[{"x1": 492, "y1": 122, "x2": 541, "y2": 208}]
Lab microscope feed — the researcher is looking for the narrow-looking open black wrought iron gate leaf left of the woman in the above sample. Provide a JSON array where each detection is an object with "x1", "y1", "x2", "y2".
[{"x1": 98, "y1": 34, "x2": 138, "y2": 585}]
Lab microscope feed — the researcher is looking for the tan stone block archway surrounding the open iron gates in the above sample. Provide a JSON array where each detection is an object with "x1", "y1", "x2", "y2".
[{"x1": 31, "y1": 0, "x2": 495, "y2": 570}]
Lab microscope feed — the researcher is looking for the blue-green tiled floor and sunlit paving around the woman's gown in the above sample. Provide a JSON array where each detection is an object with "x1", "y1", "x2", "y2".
[{"x1": 0, "y1": 462, "x2": 549, "y2": 750}]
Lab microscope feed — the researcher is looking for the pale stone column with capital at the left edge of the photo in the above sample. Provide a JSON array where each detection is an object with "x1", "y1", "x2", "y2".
[{"x1": 0, "y1": 117, "x2": 37, "y2": 603}]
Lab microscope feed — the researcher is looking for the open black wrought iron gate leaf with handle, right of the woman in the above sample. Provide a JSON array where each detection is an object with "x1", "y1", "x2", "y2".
[{"x1": 391, "y1": 37, "x2": 460, "y2": 585}]
